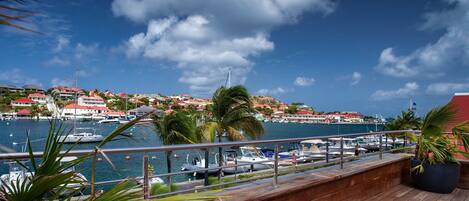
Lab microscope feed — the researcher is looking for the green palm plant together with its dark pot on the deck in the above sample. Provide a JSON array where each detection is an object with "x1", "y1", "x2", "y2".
[{"x1": 411, "y1": 104, "x2": 469, "y2": 193}]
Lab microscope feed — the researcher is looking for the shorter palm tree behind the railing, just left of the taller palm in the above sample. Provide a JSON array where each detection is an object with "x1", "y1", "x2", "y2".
[{"x1": 153, "y1": 112, "x2": 202, "y2": 190}]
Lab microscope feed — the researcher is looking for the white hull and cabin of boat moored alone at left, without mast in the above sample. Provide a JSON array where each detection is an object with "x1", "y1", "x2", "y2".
[{"x1": 60, "y1": 128, "x2": 104, "y2": 143}]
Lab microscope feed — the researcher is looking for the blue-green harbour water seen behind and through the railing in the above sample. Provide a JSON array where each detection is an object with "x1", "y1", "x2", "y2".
[{"x1": 0, "y1": 120, "x2": 381, "y2": 188}]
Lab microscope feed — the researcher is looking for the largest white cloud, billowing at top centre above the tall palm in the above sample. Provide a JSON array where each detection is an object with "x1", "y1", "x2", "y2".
[{"x1": 112, "y1": 0, "x2": 335, "y2": 93}]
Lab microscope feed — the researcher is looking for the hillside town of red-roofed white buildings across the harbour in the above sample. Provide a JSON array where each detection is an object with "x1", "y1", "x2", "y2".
[{"x1": 0, "y1": 84, "x2": 384, "y2": 124}]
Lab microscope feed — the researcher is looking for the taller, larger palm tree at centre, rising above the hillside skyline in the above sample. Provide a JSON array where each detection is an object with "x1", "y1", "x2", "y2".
[{"x1": 201, "y1": 85, "x2": 264, "y2": 175}]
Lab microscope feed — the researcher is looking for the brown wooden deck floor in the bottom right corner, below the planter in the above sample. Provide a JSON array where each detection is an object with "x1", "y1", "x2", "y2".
[{"x1": 367, "y1": 184, "x2": 469, "y2": 201}]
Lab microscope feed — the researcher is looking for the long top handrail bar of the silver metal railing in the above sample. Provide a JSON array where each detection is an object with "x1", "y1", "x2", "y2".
[{"x1": 0, "y1": 130, "x2": 414, "y2": 160}]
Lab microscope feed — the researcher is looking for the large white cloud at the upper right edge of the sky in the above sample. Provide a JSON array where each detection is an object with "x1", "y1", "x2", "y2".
[{"x1": 376, "y1": 0, "x2": 469, "y2": 77}]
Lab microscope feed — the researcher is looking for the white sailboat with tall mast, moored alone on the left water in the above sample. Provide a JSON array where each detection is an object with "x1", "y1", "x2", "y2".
[{"x1": 60, "y1": 73, "x2": 104, "y2": 143}]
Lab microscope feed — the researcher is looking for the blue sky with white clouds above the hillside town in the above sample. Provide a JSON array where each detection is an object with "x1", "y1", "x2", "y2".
[{"x1": 0, "y1": 0, "x2": 469, "y2": 117}]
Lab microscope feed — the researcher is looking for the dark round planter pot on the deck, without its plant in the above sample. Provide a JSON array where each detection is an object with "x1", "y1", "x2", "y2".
[{"x1": 411, "y1": 158, "x2": 461, "y2": 193}]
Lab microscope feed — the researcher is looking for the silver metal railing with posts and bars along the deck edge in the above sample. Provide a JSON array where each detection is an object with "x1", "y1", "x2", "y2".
[{"x1": 0, "y1": 130, "x2": 414, "y2": 199}]
